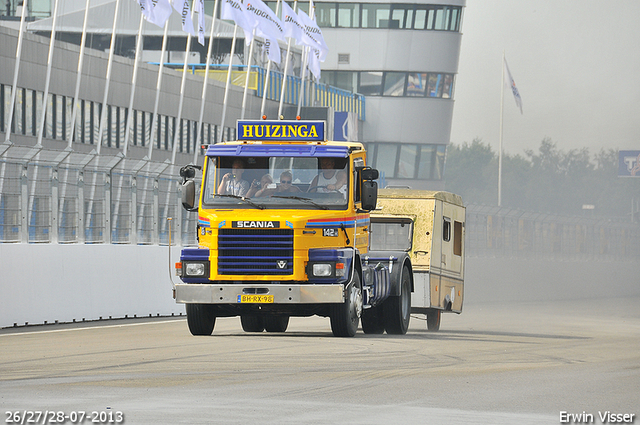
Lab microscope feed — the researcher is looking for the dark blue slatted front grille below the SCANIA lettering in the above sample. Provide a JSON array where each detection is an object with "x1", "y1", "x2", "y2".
[{"x1": 218, "y1": 229, "x2": 293, "y2": 275}]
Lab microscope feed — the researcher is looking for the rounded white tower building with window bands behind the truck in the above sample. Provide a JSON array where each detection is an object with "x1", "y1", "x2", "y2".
[{"x1": 315, "y1": 0, "x2": 466, "y2": 189}]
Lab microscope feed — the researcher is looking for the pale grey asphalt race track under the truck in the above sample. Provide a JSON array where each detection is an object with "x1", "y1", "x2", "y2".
[{"x1": 0, "y1": 298, "x2": 640, "y2": 425}]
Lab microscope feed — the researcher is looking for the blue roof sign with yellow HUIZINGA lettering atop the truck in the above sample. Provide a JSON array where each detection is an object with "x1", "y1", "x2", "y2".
[{"x1": 237, "y1": 120, "x2": 325, "y2": 142}]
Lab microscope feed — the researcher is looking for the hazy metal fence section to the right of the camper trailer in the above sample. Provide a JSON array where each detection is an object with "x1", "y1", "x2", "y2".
[{"x1": 466, "y1": 205, "x2": 640, "y2": 261}]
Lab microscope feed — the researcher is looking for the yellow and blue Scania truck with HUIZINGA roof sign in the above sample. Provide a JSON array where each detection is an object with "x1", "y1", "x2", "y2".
[{"x1": 174, "y1": 120, "x2": 464, "y2": 336}]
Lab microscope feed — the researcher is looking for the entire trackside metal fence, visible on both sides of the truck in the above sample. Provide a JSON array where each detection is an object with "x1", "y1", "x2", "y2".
[{"x1": 0, "y1": 145, "x2": 640, "y2": 261}]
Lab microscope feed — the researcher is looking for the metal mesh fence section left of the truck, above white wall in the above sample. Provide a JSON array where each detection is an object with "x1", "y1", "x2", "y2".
[{"x1": 0, "y1": 146, "x2": 197, "y2": 245}]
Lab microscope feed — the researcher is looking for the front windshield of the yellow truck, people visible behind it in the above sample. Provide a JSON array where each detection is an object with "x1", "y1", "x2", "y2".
[{"x1": 202, "y1": 156, "x2": 349, "y2": 209}]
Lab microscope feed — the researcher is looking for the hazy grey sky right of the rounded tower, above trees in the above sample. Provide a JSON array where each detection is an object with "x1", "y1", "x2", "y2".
[{"x1": 451, "y1": 0, "x2": 640, "y2": 154}]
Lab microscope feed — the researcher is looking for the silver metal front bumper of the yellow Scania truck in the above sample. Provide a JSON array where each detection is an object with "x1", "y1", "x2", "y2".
[{"x1": 176, "y1": 282, "x2": 345, "y2": 304}]
